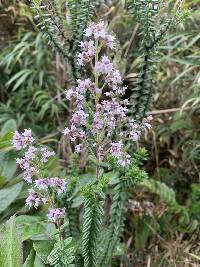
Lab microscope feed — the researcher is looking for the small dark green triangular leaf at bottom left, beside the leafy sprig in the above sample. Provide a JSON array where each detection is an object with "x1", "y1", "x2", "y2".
[{"x1": 33, "y1": 240, "x2": 54, "y2": 263}]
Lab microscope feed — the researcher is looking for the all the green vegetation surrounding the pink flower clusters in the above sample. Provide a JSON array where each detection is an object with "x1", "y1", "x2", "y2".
[{"x1": 0, "y1": 0, "x2": 200, "y2": 267}]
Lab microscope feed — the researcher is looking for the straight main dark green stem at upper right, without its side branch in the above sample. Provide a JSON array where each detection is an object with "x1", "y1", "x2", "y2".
[{"x1": 128, "y1": 0, "x2": 158, "y2": 120}]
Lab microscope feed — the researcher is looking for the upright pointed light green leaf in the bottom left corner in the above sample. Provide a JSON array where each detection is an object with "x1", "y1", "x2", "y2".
[{"x1": 0, "y1": 216, "x2": 22, "y2": 267}]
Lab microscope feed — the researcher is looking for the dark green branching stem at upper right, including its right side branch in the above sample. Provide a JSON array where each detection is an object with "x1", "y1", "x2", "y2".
[{"x1": 128, "y1": 0, "x2": 187, "y2": 120}]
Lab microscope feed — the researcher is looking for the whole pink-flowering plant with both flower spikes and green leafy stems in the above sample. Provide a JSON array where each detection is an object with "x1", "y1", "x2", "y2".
[{"x1": 13, "y1": 21, "x2": 152, "y2": 267}]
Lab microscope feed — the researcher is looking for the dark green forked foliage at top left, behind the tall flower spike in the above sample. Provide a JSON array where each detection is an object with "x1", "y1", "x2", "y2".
[{"x1": 32, "y1": 0, "x2": 92, "y2": 83}]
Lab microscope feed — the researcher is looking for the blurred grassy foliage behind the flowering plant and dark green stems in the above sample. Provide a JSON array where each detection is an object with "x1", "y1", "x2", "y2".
[{"x1": 0, "y1": 0, "x2": 200, "y2": 267}]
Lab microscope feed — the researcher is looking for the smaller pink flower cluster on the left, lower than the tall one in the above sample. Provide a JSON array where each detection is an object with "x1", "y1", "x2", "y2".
[{"x1": 12, "y1": 130, "x2": 67, "y2": 223}]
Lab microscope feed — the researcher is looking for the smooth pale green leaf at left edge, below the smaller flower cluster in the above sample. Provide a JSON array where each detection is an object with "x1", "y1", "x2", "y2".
[{"x1": 0, "y1": 183, "x2": 23, "y2": 212}]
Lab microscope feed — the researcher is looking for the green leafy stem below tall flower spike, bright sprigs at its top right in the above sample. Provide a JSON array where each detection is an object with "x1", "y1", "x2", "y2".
[{"x1": 97, "y1": 150, "x2": 147, "y2": 267}]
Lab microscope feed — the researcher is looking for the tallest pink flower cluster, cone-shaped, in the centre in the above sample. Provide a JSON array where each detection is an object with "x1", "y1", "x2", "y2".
[{"x1": 63, "y1": 21, "x2": 152, "y2": 166}]
